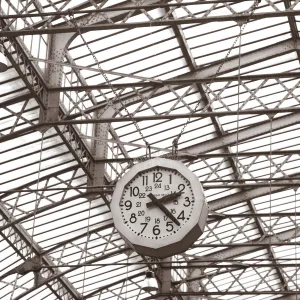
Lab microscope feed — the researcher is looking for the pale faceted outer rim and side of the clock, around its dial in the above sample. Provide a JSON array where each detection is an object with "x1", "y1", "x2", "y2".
[{"x1": 111, "y1": 158, "x2": 208, "y2": 257}]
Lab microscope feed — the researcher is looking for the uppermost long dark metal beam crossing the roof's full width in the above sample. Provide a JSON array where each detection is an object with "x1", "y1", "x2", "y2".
[{"x1": 0, "y1": 10, "x2": 300, "y2": 37}]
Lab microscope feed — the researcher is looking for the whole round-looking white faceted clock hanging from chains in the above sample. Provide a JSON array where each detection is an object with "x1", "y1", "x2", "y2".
[{"x1": 111, "y1": 158, "x2": 208, "y2": 258}]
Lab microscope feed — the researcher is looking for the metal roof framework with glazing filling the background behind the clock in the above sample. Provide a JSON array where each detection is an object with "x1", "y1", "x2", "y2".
[{"x1": 0, "y1": 0, "x2": 300, "y2": 300}]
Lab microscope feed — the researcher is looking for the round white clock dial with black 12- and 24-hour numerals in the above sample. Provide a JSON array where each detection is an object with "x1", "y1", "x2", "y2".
[{"x1": 119, "y1": 167, "x2": 195, "y2": 240}]
